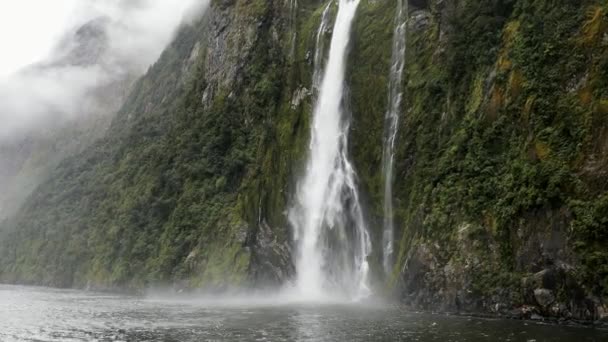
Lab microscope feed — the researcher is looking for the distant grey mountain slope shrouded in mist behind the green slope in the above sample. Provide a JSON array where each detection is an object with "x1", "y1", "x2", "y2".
[{"x1": 0, "y1": 18, "x2": 138, "y2": 220}]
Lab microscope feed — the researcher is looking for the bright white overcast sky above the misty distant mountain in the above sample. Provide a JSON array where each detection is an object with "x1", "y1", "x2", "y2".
[{"x1": 0, "y1": 0, "x2": 208, "y2": 78}]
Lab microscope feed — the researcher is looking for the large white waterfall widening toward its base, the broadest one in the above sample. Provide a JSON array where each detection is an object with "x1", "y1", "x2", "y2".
[{"x1": 289, "y1": 0, "x2": 371, "y2": 300}]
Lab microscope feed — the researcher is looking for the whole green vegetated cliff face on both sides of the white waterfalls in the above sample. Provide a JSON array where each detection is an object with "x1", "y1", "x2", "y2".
[{"x1": 0, "y1": 0, "x2": 608, "y2": 320}]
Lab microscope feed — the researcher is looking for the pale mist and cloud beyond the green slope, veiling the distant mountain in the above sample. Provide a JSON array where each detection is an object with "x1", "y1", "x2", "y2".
[{"x1": 0, "y1": 0, "x2": 209, "y2": 219}]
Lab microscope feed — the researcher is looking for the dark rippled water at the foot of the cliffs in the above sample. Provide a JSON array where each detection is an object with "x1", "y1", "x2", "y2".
[{"x1": 0, "y1": 286, "x2": 608, "y2": 342}]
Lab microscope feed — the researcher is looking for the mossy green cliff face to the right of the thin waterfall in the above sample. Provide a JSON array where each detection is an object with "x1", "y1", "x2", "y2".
[{"x1": 393, "y1": 0, "x2": 608, "y2": 320}]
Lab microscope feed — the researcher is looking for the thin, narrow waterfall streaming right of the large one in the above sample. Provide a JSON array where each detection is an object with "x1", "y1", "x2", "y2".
[{"x1": 382, "y1": 0, "x2": 407, "y2": 274}]
